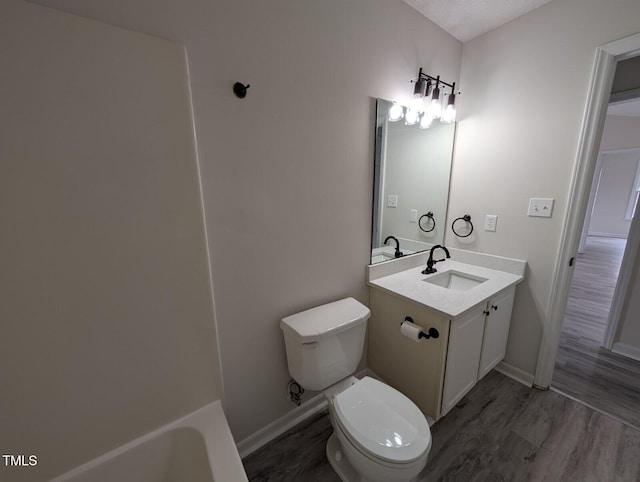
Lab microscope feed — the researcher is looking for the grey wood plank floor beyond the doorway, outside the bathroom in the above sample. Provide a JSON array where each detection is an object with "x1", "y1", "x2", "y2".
[{"x1": 551, "y1": 236, "x2": 640, "y2": 429}]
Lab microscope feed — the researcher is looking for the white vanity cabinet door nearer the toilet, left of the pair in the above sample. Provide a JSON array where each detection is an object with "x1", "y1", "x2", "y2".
[{"x1": 441, "y1": 305, "x2": 485, "y2": 416}]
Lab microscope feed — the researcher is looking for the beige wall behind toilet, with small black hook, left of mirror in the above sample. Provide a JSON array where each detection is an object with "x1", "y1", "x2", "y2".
[{"x1": 27, "y1": 0, "x2": 462, "y2": 441}]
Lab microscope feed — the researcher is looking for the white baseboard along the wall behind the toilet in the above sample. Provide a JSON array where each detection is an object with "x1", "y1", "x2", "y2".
[{"x1": 236, "y1": 368, "x2": 375, "y2": 459}]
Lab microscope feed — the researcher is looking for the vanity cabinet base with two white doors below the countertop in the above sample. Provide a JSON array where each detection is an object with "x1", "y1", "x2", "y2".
[{"x1": 368, "y1": 286, "x2": 515, "y2": 420}]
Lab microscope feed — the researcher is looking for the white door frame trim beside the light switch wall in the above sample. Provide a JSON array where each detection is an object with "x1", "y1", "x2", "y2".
[{"x1": 533, "y1": 34, "x2": 640, "y2": 389}]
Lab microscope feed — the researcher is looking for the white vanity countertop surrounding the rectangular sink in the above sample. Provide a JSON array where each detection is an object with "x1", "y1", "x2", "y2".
[{"x1": 368, "y1": 259, "x2": 524, "y2": 318}]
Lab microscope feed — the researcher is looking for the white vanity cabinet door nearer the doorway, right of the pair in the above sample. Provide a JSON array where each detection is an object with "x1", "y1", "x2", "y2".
[{"x1": 478, "y1": 286, "x2": 516, "y2": 380}]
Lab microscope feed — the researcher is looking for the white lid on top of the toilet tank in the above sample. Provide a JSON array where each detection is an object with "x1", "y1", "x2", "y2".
[{"x1": 280, "y1": 298, "x2": 371, "y2": 341}]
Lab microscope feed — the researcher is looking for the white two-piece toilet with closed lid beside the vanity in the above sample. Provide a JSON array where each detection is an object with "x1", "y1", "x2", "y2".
[{"x1": 280, "y1": 298, "x2": 431, "y2": 482}]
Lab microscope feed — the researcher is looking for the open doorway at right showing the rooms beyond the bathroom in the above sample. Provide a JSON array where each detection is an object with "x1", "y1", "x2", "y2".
[{"x1": 551, "y1": 57, "x2": 640, "y2": 429}]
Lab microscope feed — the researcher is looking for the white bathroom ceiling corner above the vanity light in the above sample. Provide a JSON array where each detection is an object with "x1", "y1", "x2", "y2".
[{"x1": 404, "y1": 0, "x2": 551, "y2": 42}]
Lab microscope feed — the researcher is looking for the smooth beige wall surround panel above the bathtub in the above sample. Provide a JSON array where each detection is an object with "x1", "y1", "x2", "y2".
[{"x1": 0, "y1": 0, "x2": 222, "y2": 481}]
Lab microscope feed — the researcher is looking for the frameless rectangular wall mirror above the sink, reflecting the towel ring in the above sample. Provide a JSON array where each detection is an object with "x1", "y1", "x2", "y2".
[{"x1": 371, "y1": 99, "x2": 455, "y2": 264}]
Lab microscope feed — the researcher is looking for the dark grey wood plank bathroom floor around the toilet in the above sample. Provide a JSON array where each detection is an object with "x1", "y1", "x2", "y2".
[{"x1": 243, "y1": 371, "x2": 640, "y2": 482}]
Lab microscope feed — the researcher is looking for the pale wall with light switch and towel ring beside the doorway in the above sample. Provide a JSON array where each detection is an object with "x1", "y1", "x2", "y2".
[{"x1": 446, "y1": 0, "x2": 640, "y2": 374}]
